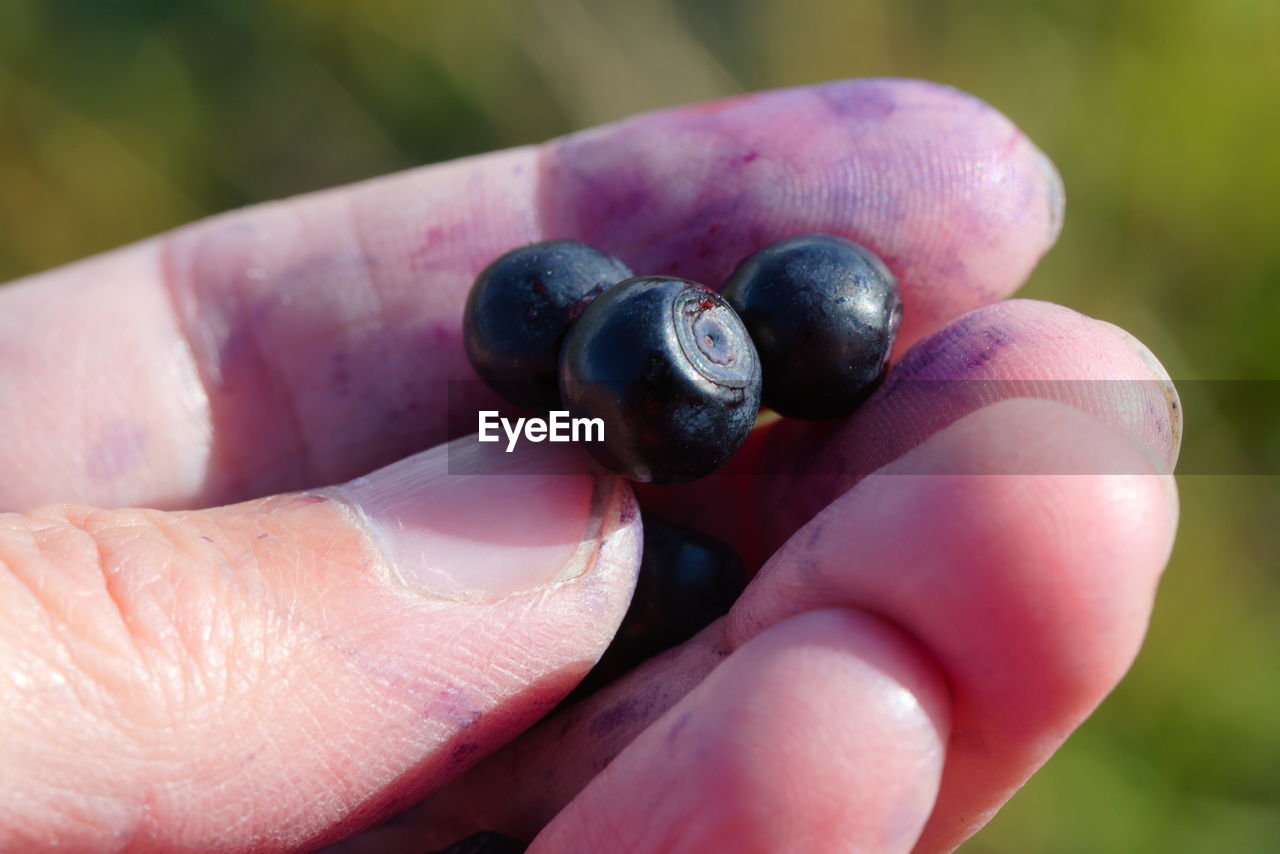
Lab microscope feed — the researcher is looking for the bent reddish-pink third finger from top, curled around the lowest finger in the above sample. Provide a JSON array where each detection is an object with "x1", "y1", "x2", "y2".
[{"x1": 357, "y1": 399, "x2": 1174, "y2": 854}]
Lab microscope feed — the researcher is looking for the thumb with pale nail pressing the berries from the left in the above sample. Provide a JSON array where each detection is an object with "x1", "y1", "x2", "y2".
[{"x1": 0, "y1": 442, "x2": 640, "y2": 853}]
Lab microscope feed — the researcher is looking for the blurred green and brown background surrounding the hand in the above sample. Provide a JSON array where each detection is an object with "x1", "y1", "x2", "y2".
[{"x1": 0, "y1": 0, "x2": 1280, "y2": 854}]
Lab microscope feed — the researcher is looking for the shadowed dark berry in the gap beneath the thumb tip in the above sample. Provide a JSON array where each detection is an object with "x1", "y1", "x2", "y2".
[{"x1": 568, "y1": 513, "x2": 748, "y2": 702}]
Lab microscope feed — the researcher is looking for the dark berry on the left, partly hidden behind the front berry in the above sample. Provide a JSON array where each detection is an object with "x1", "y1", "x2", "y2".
[{"x1": 462, "y1": 241, "x2": 631, "y2": 412}]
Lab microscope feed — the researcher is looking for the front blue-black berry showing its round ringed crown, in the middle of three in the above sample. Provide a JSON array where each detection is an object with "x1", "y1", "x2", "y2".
[{"x1": 559, "y1": 277, "x2": 760, "y2": 483}]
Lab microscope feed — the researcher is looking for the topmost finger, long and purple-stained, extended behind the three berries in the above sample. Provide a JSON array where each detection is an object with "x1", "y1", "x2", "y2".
[{"x1": 0, "y1": 79, "x2": 1061, "y2": 508}]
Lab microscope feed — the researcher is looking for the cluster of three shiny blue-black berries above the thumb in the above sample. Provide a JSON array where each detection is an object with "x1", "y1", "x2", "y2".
[{"x1": 463, "y1": 234, "x2": 902, "y2": 483}]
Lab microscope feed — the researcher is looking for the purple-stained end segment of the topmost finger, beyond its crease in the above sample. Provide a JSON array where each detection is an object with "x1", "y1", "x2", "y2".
[{"x1": 541, "y1": 78, "x2": 1062, "y2": 350}]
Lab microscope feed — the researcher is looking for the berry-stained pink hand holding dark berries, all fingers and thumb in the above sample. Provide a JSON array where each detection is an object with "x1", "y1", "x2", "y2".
[{"x1": 0, "y1": 81, "x2": 1180, "y2": 854}]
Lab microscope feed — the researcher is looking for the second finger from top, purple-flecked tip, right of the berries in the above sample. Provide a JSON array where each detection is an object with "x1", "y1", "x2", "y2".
[{"x1": 637, "y1": 300, "x2": 1183, "y2": 566}]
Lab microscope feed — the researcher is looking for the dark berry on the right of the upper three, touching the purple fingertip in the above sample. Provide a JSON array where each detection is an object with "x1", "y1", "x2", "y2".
[{"x1": 723, "y1": 234, "x2": 902, "y2": 420}]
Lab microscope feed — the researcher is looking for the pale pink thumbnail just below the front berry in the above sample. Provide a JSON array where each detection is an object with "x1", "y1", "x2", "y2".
[{"x1": 330, "y1": 437, "x2": 618, "y2": 600}]
